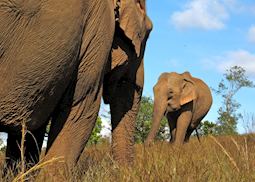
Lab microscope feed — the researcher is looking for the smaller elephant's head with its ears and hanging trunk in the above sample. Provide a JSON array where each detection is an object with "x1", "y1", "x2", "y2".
[{"x1": 147, "y1": 72, "x2": 197, "y2": 142}]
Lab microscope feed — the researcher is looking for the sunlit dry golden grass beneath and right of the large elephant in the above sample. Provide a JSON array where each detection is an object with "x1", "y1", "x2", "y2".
[{"x1": 0, "y1": 135, "x2": 255, "y2": 182}]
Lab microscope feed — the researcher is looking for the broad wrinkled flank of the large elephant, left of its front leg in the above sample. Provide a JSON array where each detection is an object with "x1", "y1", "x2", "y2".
[{"x1": 0, "y1": 0, "x2": 84, "y2": 129}]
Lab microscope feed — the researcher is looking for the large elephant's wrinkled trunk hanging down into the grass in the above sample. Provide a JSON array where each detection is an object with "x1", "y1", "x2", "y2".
[{"x1": 110, "y1": 63, "x2": 144, "y2": 164}]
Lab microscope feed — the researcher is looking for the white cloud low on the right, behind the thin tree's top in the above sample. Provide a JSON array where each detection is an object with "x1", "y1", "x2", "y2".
[{"x1": 214, "y1": 50, "x2": 255, "y2": 77}]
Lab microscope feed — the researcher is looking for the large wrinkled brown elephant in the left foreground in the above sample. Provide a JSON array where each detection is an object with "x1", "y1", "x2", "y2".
[{"x1": 0, "y1": 0, "x2": 152, "y2": 176}]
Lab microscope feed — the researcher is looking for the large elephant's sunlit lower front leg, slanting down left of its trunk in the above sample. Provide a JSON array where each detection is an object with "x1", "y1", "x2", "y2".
[{"x1": 45, "y1": 84, "x2": 102, "y2": 173}]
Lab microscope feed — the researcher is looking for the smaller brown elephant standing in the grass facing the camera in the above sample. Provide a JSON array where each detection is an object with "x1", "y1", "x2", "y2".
[{"x1": 146, "y1": 72, "x2": 212, "y2": 145}]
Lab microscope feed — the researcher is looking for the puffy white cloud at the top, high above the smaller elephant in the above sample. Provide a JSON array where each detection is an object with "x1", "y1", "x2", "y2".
[{"x1": 171, "y1": 0, "x2": 229, "y2": 30}]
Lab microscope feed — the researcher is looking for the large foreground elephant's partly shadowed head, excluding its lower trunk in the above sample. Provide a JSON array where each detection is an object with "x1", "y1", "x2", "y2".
[{"x1": 104, "y1": 0, "x2": 152, "y2": 103}]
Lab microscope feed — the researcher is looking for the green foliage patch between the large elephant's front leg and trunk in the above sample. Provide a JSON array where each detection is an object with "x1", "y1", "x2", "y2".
[{"x1": 88, "y1": 116, "x2": 103, "y2": 145}]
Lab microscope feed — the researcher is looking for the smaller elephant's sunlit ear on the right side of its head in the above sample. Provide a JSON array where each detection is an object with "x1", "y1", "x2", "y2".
[{"x1": 180, "y1": 72, "x2": 197, "y2": 105}]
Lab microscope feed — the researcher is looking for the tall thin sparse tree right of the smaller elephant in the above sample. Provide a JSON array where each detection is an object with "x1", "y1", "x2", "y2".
[{"x1": 213, "y1": 66, "x2": 254, "y2": 135}]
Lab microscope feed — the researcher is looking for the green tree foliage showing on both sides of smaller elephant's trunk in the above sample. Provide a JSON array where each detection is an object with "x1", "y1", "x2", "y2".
[{"x1": 135, "y1": 97, "x2": 169, "y2": 143}]
